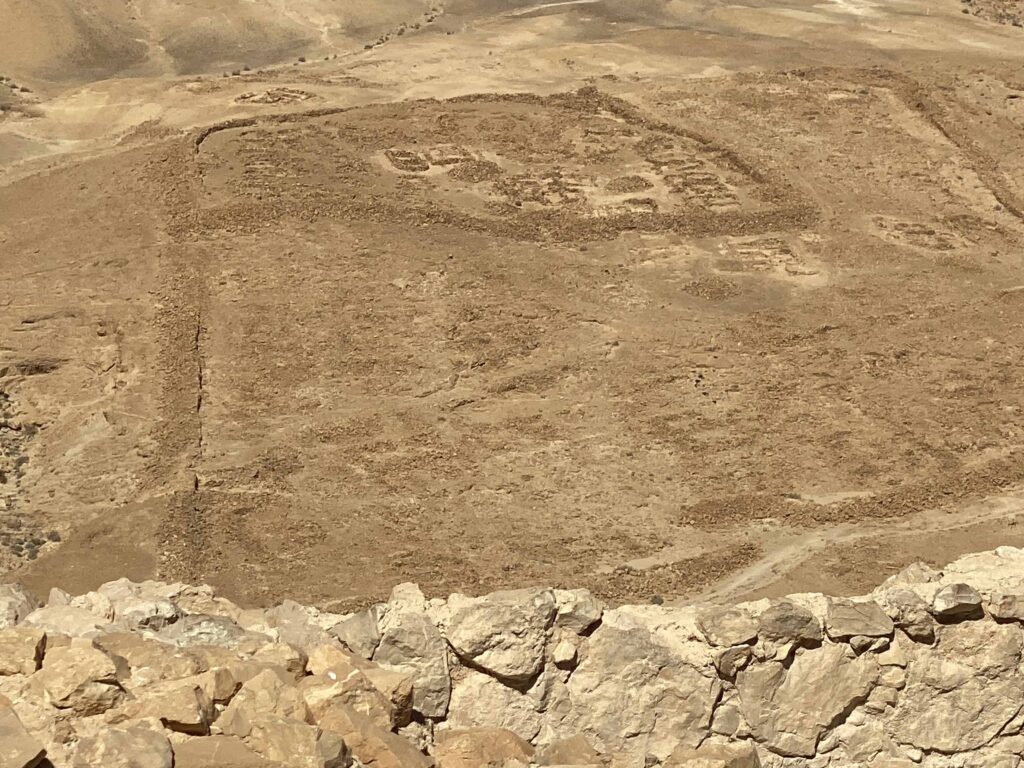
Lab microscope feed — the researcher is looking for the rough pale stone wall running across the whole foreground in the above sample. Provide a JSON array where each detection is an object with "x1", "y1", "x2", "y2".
[{"x1": 0, "y1": 548, "x2": 1024, "y2": 768}]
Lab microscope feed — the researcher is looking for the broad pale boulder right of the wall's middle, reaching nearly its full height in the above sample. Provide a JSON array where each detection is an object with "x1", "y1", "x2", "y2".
[{"x1": 565, "y1": 618, "x2": 721, "y2": 759}]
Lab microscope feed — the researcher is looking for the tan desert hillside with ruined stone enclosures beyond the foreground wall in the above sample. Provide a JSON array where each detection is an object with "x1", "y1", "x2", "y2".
[{"x1": 0, "y1": 0, "x2": 1024, "y2": 609}]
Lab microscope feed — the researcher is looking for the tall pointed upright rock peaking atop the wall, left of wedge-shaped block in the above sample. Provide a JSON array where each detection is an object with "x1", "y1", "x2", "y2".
[{"x1": 373, "y1": 585, "x2": 452, "y2": 718}]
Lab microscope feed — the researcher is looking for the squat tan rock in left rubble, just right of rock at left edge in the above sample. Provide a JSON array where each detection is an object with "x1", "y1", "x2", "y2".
[{"x1": 40, "y1": 645, "x2": 124, "y2": 717}]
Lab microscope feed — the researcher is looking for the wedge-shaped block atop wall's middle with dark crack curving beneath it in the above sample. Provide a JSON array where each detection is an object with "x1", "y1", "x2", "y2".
[{"x1": 445, "y1": 589, "x2": 556, "y2": 681}]
